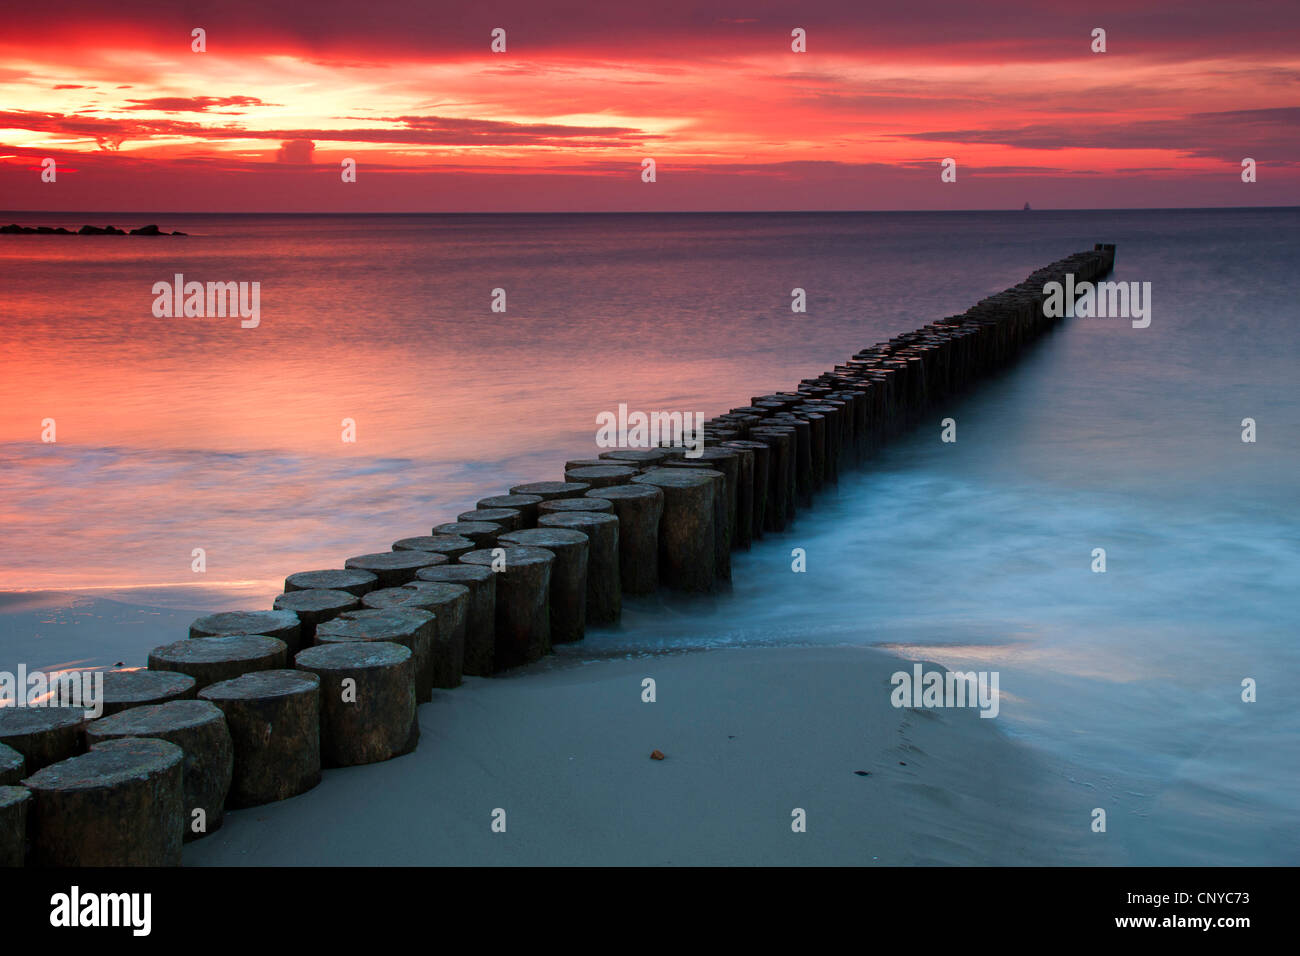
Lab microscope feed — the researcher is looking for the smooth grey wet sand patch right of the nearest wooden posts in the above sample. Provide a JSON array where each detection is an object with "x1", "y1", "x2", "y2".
[{"x1": 185, "y1": 646, "x2": 1108, "y2": 866}]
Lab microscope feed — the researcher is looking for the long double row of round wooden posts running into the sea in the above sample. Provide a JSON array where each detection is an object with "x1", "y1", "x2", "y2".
[{"x1": 0, "y1": 245, "x2": 1114, "y2": 866}]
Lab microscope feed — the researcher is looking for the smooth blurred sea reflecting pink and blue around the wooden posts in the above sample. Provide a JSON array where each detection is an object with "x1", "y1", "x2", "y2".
[{"x1": 0, "y1": 209, "x2": 1300, "y2": 864}]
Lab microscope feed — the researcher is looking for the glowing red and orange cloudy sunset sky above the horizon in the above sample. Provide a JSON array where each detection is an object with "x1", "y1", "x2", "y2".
[{"x1": 0, "y1": 0, "x2": 1300, "y2": 212}]
